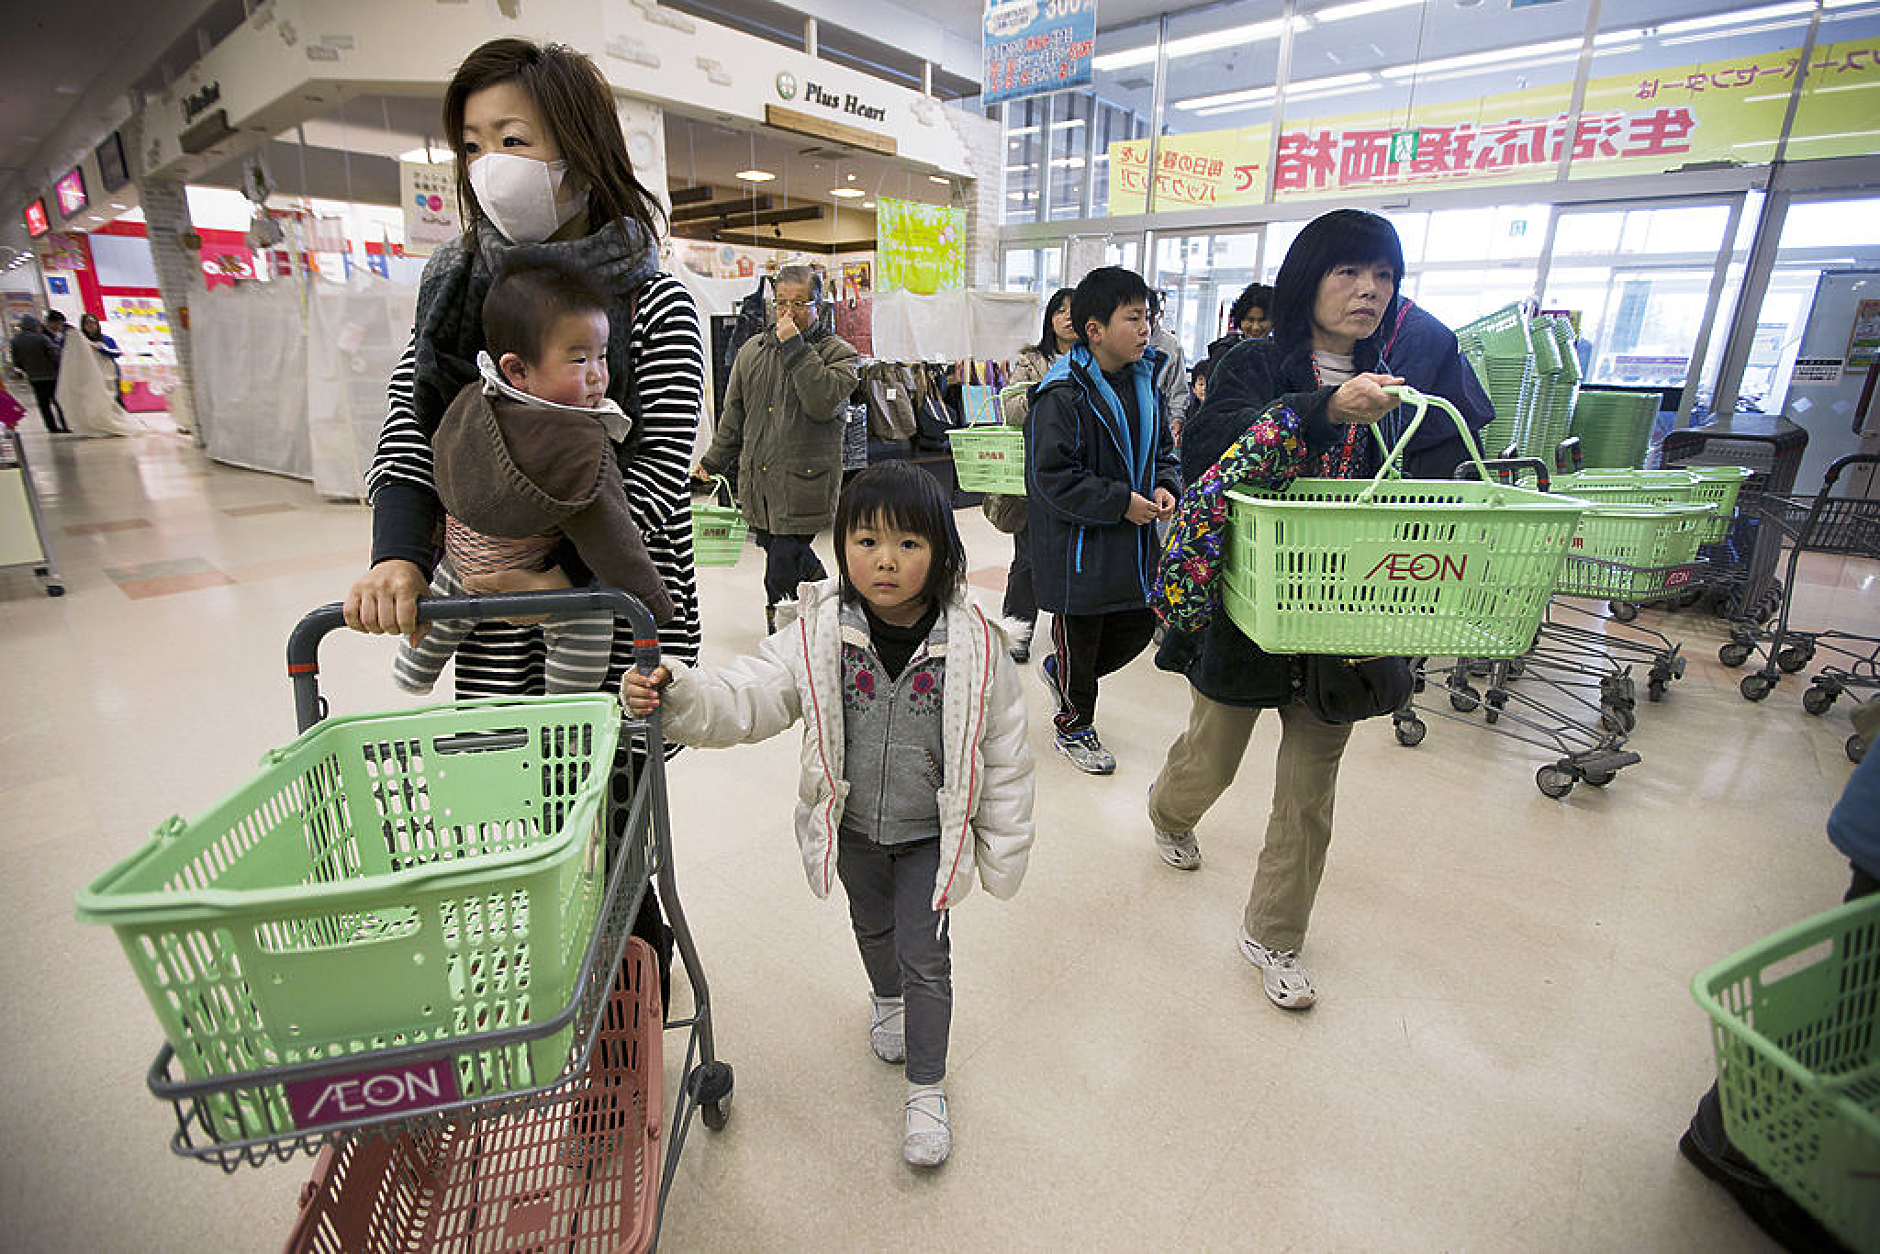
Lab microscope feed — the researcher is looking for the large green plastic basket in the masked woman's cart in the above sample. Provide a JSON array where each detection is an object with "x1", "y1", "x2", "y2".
[{"x1": 77, "y1": 694, "x2": 620, "y2": 1139}]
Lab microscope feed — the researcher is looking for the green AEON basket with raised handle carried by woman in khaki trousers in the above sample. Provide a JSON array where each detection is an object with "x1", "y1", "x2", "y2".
[{"x1": 1222, "y1": 387, "x2": 1587, "y2": 658}]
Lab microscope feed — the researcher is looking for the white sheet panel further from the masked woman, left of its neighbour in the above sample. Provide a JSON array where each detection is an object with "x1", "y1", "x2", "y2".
[{"x1": 190, "y1": 282, "x2": 312, "y2": 479}]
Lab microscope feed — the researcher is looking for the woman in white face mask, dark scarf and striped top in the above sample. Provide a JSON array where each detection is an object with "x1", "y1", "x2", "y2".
[{"x1": 346, "y1": 39, "x2": 705, "y2": 985}]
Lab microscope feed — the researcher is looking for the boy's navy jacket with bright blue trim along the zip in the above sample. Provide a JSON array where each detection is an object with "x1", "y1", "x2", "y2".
[{"x1": 1025, "y1": 344, "x2": 1181, "y2": 615}]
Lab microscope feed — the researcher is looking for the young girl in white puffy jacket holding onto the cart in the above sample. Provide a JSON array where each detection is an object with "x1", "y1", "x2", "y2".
[{"x1": 620, "y1": 462, "x2": 1032, "y2": 1168}]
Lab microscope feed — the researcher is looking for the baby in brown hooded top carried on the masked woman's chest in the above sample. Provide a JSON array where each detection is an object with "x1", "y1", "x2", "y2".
[{"x1": 393, "y1": 248, "x2": 673, "y2": 692}]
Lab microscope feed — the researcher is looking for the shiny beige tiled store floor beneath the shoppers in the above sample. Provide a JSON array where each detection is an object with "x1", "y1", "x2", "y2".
[{"x1": 0, "y1": 407, "x2": 1880, "y2": 1252}]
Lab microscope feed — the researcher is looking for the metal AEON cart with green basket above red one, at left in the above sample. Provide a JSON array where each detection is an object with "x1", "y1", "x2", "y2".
[{"x1": 79, "y1": 590, "x2": 731, "y2": 1250}]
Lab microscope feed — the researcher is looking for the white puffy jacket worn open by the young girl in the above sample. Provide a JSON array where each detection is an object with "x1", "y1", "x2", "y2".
[{"x1": 660, "y1": 579, "x2": 1032, "y2": 910}]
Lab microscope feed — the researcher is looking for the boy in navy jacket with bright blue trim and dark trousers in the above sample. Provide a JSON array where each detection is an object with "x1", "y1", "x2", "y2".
[{"x1": 1025, "y1": 265, "x2": 1181, "y2": 775}]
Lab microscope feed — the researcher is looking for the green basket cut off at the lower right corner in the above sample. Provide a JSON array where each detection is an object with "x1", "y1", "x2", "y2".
[{"x1": 1690, "y1": 897, "x2": 1880, "y2": 1254}]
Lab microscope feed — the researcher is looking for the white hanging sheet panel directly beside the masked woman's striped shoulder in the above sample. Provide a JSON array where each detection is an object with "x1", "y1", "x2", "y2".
[{"x1": 306, "y1": 269, "x2": 417, "y2": 500}]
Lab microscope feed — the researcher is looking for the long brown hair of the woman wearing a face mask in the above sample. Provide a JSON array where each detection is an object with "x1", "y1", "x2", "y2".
[{"x1": 444, "y1": 39, "x2": 666, "y2": 252}]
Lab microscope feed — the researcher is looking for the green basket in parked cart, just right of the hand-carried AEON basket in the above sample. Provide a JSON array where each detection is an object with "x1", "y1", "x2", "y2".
[{"x1": 1557, "y1": 500, "x2": 1713, "y2": 602}]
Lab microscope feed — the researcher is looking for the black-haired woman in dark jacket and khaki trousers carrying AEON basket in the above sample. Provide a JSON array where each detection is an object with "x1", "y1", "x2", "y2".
[{"x1": 1149, "y1": 209, "x2": 1404, "y2": 1010}]
